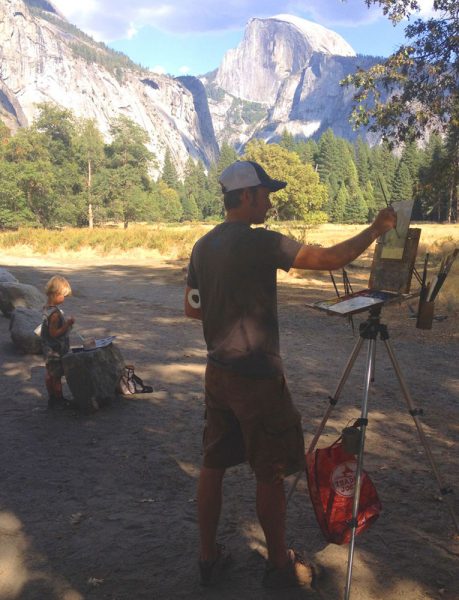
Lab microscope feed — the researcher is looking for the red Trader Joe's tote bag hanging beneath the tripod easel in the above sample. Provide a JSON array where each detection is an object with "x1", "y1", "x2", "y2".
[{"x1": 306, "y1": 438, "x2": 382, "y2": 545}]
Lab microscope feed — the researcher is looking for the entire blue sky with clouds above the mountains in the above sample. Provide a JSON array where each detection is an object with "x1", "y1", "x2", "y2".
[{"x1": 53, "y1": 0, "x2": 430, "y2": 75}]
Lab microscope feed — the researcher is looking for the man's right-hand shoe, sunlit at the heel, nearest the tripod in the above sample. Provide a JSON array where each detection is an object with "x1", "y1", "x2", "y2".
[{"x1": 263, "y1": 550, "x2": 317, "y2": 590}]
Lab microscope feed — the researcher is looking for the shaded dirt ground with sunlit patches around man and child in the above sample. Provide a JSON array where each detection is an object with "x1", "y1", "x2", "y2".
[{"x1": 0, "y1": 254, "x2": 459, "y2": 600}]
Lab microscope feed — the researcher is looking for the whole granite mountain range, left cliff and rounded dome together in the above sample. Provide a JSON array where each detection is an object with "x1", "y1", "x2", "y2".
[{"x1": 0, "y1": 0, "x2": 386, "y2": 173}]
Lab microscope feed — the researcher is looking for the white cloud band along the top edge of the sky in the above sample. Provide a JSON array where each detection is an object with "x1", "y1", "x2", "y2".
[{"x1": 49, "y1": 0, "x2": 432, "y2": 41}]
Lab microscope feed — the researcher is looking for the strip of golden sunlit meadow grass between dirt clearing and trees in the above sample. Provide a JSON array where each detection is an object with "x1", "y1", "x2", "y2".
[{"x1": 0, "y1": 221, "x2": 459, "y2": 310}]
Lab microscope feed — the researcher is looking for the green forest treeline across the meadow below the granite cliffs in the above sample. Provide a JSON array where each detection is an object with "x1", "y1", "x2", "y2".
[{"x1": 0, "y1": 104, "x2": 456, "y2": 229}]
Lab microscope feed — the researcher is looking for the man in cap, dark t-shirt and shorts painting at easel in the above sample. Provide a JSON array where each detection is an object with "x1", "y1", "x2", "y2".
[{"x1": 185, "y1": 161, "x2": 396, "y2": 588}]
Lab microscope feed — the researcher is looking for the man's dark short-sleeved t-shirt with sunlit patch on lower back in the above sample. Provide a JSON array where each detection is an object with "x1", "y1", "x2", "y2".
[{"x1": 187, "y1": 222, "x2": 301, "y2": 378}]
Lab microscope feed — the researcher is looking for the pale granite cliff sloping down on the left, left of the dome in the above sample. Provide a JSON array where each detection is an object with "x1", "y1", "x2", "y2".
[{"x1": 0, "y1": 0, "x2": 218, "y2": 170}]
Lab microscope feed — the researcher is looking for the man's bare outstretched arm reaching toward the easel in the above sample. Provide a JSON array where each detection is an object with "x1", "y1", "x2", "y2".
[{"x1": 292, "y1": 208, "x2": 397, "y2": 271}]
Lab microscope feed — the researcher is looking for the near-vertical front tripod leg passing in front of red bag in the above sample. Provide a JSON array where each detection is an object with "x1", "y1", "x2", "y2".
[{"x1": 344, "y1": 338, "x2": 376, "y2": 600}]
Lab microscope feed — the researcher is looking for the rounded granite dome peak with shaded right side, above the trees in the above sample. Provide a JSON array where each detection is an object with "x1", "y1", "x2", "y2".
[{"x1": 203, "y1": 15, "x2": 377, "y2": 146}]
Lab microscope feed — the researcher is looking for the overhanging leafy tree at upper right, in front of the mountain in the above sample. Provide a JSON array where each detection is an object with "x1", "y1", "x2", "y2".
[{"x1": 342, "y1": 0, "x2": 459, "y2": 221}]
